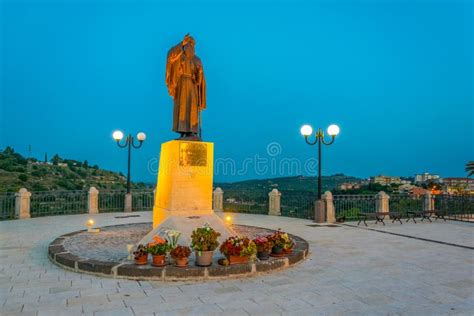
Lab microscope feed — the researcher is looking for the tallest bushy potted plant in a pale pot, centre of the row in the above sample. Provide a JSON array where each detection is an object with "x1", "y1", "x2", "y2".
[{"x1": 191, "y1": 224, "x2": 221, "y2": 267}]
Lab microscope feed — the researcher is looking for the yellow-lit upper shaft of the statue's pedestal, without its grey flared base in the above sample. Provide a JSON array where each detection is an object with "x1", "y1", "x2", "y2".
[{"x1": 153, "y1": 140, "x2": 214, "y2": 228}]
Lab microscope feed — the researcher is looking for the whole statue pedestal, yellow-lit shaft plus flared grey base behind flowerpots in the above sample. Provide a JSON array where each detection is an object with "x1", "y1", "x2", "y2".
[{"x1": 140, "y1": 140, "x2": 235, "y2": 245}]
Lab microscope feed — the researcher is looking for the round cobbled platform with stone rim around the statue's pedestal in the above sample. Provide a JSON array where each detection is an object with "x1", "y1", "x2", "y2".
[{"x1": 48, "y1": 223, "x2": 308, "y2": 280}]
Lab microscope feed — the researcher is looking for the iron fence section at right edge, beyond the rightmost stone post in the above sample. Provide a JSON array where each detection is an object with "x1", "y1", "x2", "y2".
[{"x1": 434, "y1": 195, "x2": 474, "y2": 222}]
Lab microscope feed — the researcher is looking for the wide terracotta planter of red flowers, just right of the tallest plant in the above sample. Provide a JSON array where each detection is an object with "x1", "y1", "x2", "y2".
[{"x1": 220, "y1": 236, "x2": 257, "y2": 264}]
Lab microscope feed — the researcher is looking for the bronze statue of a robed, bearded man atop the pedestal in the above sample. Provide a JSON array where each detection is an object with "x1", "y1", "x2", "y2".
[{"x1": 166, "y1": 34, "x2": 206, "y2": 140}]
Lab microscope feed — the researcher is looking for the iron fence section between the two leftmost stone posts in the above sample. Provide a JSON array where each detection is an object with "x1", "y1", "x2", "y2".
[{"x1": 30, "y1": 191, "x2": 88, "y2": 217}]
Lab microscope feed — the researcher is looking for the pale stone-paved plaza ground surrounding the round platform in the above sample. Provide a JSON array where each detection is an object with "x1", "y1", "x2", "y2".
[{"x1": 0, "y1": 212, "x2": 474, "y2": 315}]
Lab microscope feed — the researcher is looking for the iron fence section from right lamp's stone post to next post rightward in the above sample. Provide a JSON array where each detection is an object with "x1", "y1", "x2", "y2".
[{"x1": 333, "y1": 194, "x2": 376, "y2": 221}]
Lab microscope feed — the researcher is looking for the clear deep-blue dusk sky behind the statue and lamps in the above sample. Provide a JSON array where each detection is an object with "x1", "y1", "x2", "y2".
[{"x1": 0, "y1": 0, "x2": 474, "y2": 182}]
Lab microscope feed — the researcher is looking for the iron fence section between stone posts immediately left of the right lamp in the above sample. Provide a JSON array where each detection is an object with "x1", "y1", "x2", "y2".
[{"x1": 280, "y1": 191, "x2": 316, "y2": 219}]
